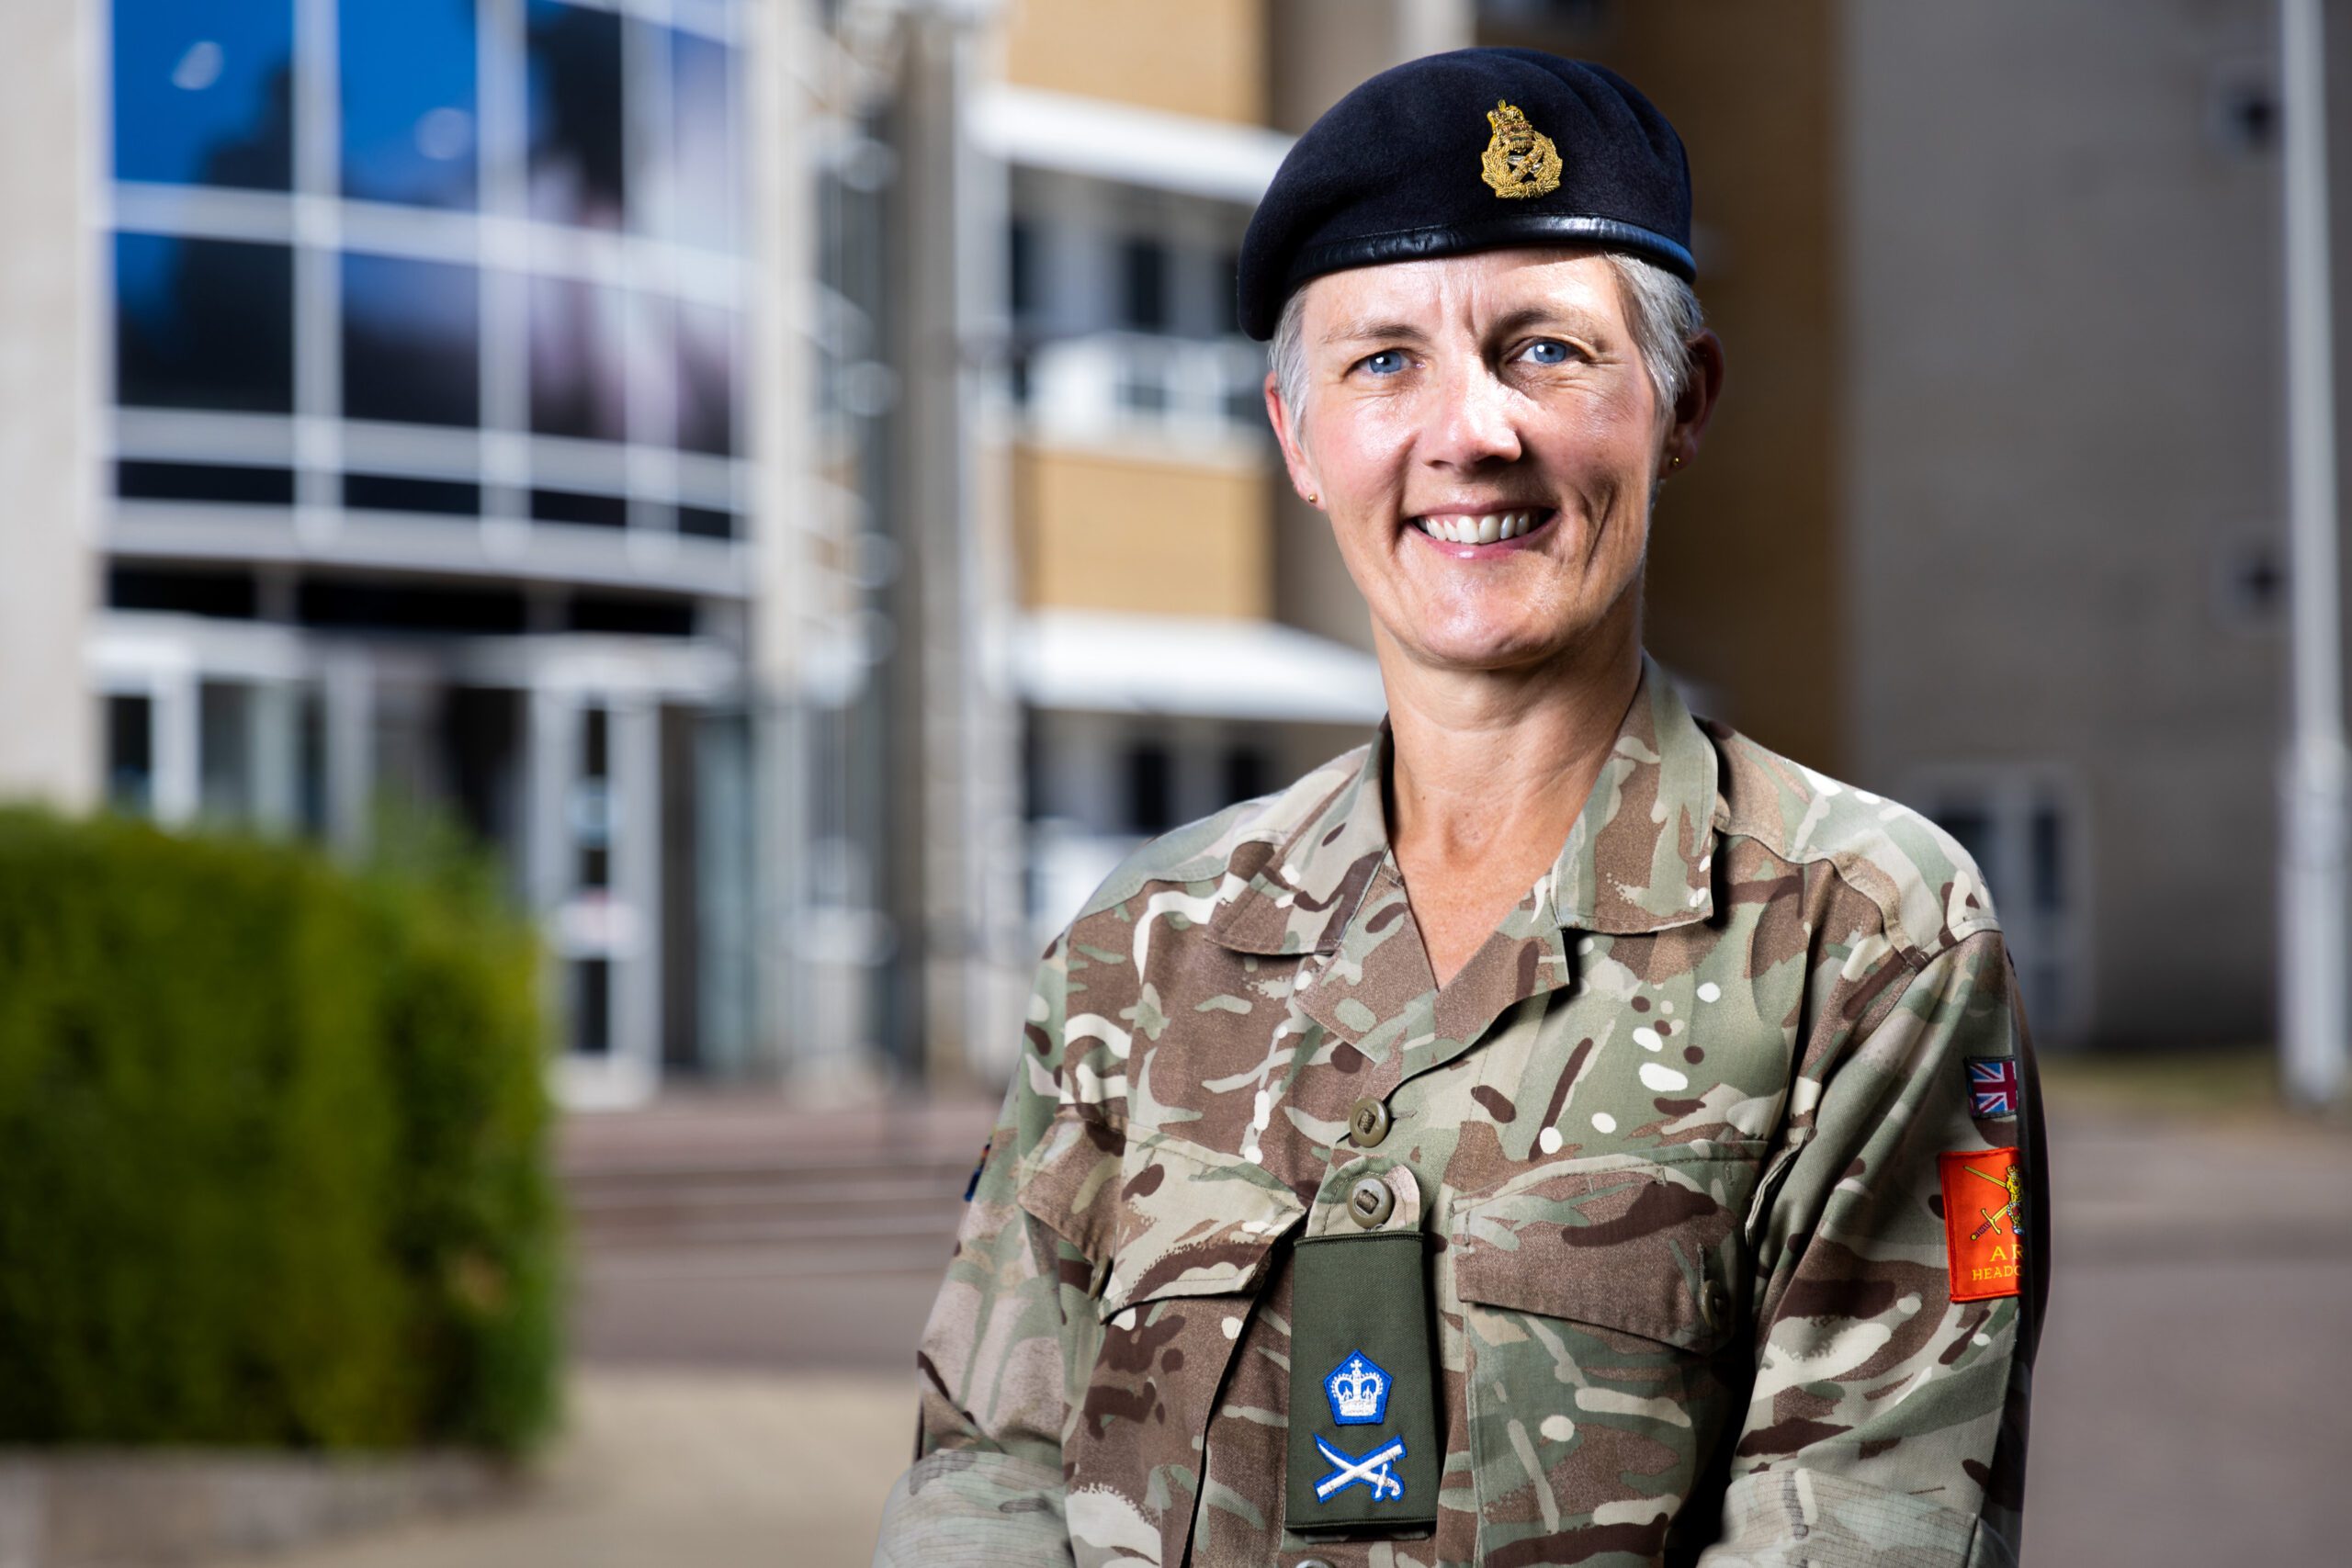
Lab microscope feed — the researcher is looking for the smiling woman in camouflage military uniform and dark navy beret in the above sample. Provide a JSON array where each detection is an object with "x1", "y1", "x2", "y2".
[{"x1": 877, "y1": 50, "x2": 2046, "y2": 1568}]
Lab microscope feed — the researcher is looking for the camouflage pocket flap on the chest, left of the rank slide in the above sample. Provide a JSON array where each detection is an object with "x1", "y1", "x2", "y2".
[{"x1": 1096, "y1": 1140, "x2": 1307, "y2": 1319}]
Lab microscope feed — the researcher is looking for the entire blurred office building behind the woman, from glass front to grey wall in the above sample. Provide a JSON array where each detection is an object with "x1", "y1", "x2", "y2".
[{"x1": 0, "y1": 0, "x2": 2352, "y2": 1102}]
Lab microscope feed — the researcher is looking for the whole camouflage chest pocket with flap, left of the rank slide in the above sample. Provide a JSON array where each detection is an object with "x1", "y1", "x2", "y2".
[{"x1": 1023, "y1": 1140, "x2": 1306, "y2": 1568}]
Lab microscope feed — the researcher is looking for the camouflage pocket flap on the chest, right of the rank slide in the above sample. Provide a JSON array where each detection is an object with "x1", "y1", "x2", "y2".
[{"x1": 1453, "y1": 1155, "x2": 1752, "y2": 1349}]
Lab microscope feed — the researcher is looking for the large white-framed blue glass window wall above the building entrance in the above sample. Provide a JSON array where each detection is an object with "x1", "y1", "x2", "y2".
[{"x1": 110, "y1": 0, "x2": 751, "y2": 541}]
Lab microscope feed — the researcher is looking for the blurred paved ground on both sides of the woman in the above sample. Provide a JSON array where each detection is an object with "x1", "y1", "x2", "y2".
[{"x1": 233, "y1": 1100, "x2": 2352, "y2": 1568}]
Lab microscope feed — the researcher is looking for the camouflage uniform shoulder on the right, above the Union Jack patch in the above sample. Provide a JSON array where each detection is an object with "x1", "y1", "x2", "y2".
[{"x1": 1705, "y1": 722, "x2": 2002, "y2": 964}]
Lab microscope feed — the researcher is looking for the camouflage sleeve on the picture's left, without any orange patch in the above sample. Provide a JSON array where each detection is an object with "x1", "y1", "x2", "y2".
[{"x1": 875, "y1": 942, "x2": 1093, "y2": 1568}]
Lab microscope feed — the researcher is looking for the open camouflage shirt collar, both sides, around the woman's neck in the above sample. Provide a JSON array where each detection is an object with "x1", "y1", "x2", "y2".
[{"x1": 1209, "y1": 653, "x2": 1717, "y2": 954}]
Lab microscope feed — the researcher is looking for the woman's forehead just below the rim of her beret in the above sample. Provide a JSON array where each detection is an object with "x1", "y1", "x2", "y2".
[{"x1": 1301, "y1": 249, "x2": 1628, "y2": 344}]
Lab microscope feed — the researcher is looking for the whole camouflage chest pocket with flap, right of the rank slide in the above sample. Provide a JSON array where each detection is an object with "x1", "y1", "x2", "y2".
[{"x1": 1449, "y1": 1145, "x2": 1755, "y2": 1561}]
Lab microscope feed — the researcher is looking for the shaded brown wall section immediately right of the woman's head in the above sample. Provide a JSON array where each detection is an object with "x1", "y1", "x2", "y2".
[{"x1": 1543, "y1": 0, "x2": 1847, "y2": 773}]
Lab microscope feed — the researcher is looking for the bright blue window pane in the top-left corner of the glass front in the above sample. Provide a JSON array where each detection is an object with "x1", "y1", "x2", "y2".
[{"x1": 113, "y1": 0, "x2": 294, "y2": 190}]
